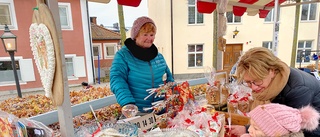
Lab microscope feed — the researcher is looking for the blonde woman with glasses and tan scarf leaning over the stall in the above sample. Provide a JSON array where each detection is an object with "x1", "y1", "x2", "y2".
[{"x1": 231, "y1": 47, "x2": 320, "y2": 137}]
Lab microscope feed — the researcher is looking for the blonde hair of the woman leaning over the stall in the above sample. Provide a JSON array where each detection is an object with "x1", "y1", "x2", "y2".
[{"x1": 236, "y1": 47, "x2": 284, "y2": 82}]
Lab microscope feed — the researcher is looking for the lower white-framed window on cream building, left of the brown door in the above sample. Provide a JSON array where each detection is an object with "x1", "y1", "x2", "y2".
[{"x1": 188, "y1": 44, "x2": 203, "y2": 67}]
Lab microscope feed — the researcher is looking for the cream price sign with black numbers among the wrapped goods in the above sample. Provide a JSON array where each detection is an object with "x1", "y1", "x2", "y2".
[{"x1": 130, "y1": 113, "x2": 156, "y2": 130}]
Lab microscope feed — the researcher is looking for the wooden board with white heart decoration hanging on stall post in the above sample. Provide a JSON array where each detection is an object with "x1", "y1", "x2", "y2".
[{"x1": 29, "y1": 0, "x2": 64, "y2": 106}]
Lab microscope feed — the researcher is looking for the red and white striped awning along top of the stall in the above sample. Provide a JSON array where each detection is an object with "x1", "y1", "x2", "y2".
[{"x1": 117, "y1": 0, "x2": 286, "y2": 18}]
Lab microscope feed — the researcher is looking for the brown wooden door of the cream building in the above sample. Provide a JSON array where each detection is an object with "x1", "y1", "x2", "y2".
[{"x1": 223, "y1": 44, "x2": 243, "y2": 74}]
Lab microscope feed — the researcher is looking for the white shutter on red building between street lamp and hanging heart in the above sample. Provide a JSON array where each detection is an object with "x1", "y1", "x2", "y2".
[{"x1": 19, "y1": 59, "x2": 36, "y2": 81}]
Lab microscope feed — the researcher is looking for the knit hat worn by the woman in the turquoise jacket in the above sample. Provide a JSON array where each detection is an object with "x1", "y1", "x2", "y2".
[{"x1": 131, "y1": 16, "x2": 156, "y2": 40}]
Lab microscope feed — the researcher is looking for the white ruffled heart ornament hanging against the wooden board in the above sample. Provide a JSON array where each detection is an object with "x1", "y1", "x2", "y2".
[{"x1": 29, "y1": 23, "x2": 55, "y2": 97}]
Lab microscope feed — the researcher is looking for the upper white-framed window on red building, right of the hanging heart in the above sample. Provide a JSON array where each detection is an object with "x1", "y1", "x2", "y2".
[{"x1": 58, "y1": 2, "x2": 73, "y2": 30}]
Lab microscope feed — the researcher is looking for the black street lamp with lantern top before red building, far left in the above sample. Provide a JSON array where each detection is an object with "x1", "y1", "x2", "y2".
[{"x1": 0, "y1": 24, "x2": 22, "y2": 98}]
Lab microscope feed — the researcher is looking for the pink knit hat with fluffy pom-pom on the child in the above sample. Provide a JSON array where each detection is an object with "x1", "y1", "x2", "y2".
[{"x1": 248, "y1": 103, "x2": 320, "y2": 136}]
